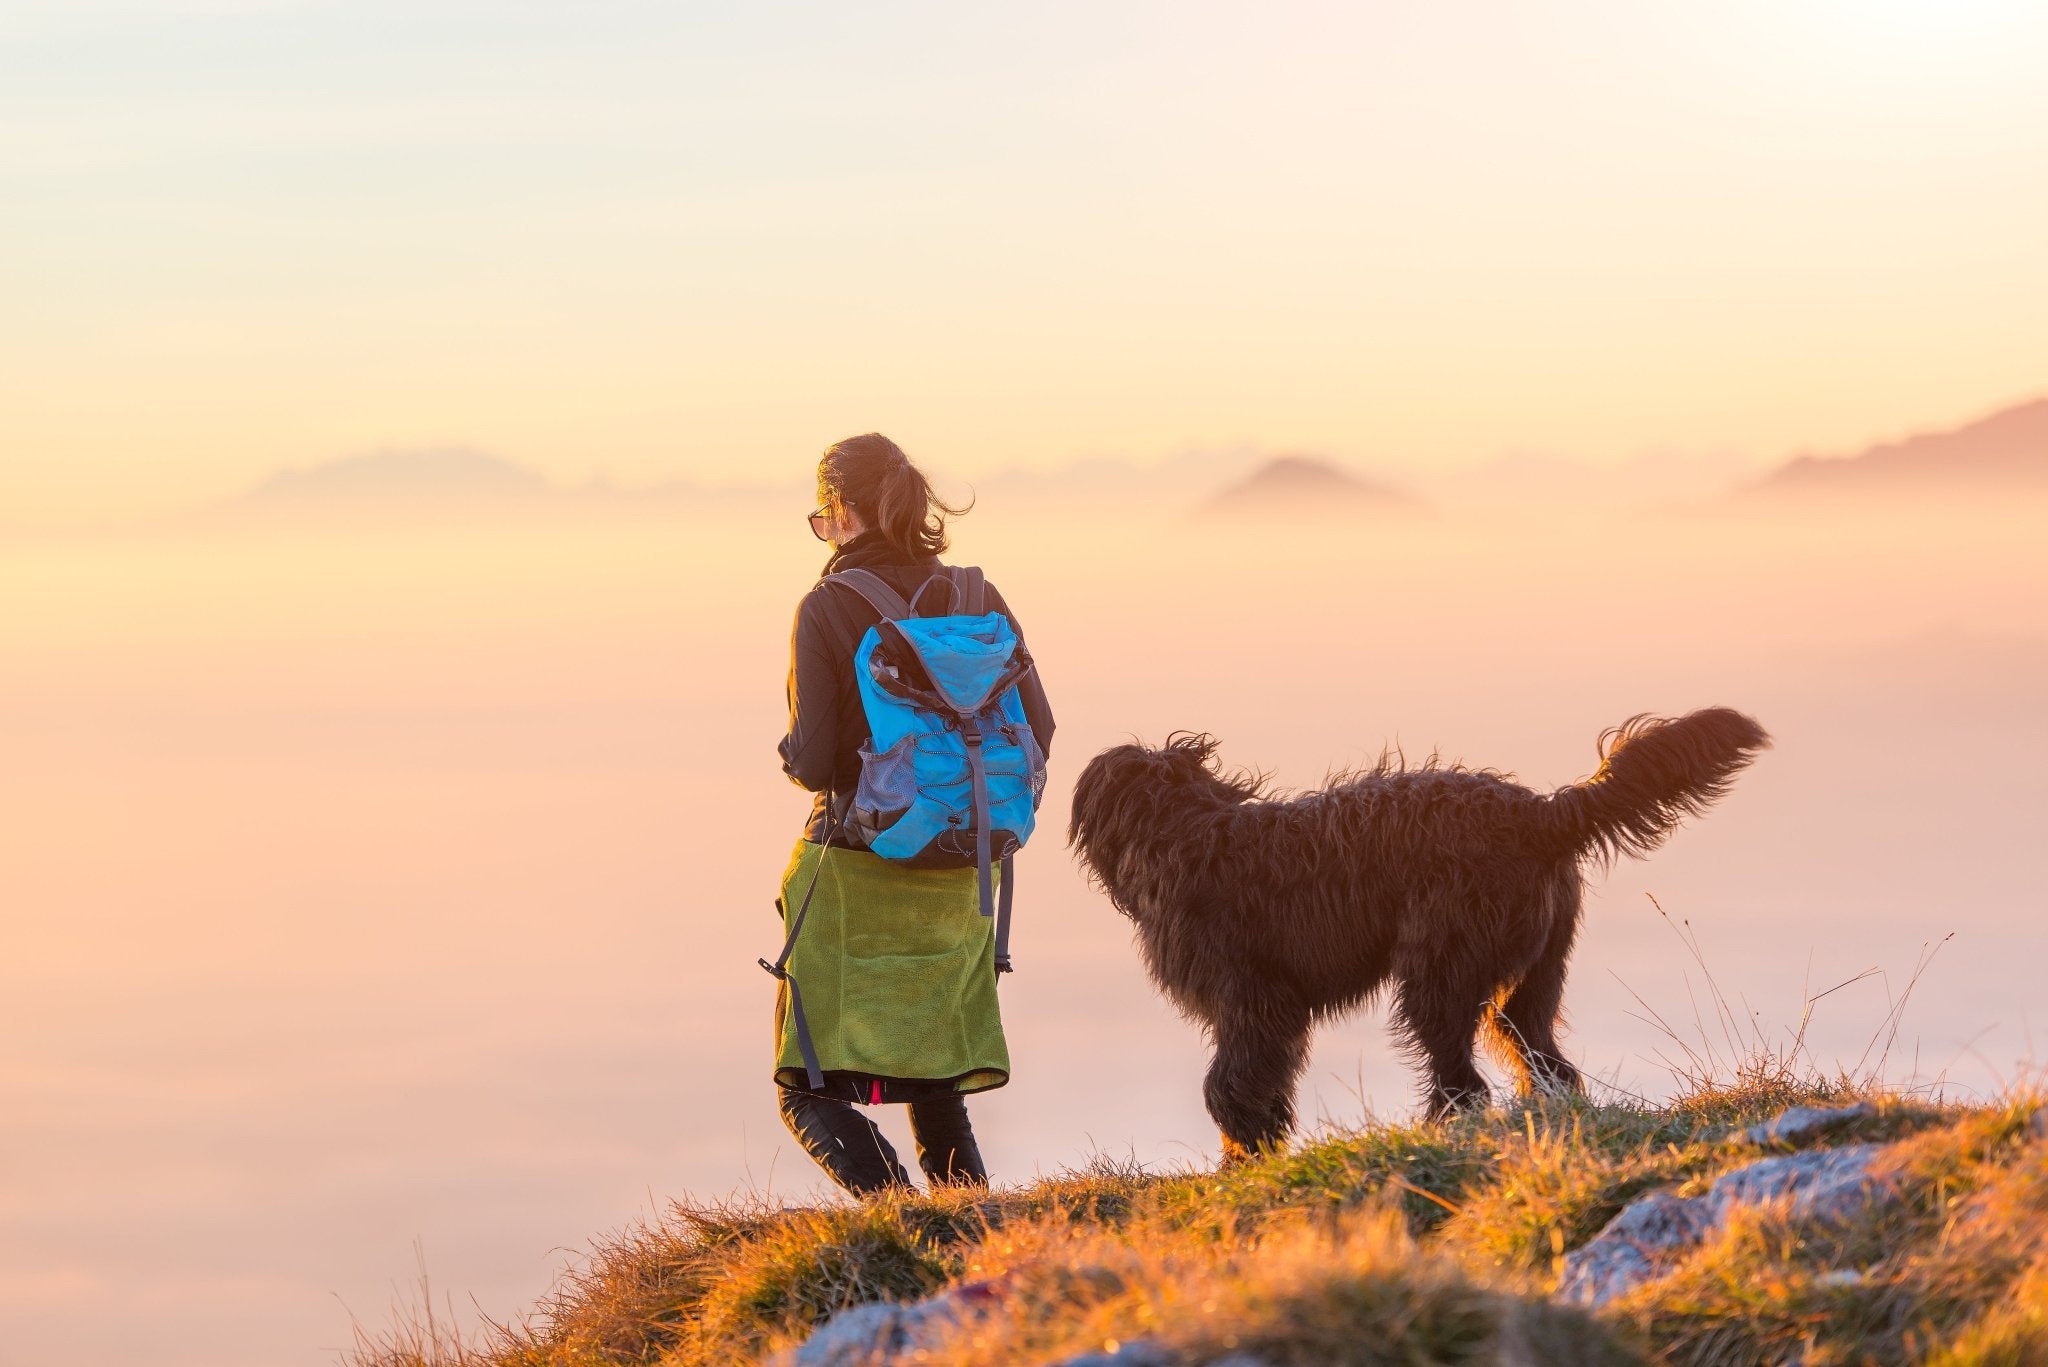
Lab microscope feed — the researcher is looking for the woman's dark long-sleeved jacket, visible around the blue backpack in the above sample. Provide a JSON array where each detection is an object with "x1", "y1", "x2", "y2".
[{"x1": 778, "y1": 531, "x2": 1053, "y2": 848}]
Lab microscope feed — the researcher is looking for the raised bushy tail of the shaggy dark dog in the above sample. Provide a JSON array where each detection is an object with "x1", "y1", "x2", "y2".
[{"x1": 1548, "y1": 707, "x2": 1772, "y2": 863}]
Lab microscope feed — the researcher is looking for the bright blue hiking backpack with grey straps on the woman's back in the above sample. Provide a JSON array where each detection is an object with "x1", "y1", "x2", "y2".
[{"x1": 825, "y1": 568, "x2": 1044, "y2": 974}]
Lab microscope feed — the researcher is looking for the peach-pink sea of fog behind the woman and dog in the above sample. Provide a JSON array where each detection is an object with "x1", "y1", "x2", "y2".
[{"x1": 0, "y1": 502, "x2": 2048, "y2": 1365}]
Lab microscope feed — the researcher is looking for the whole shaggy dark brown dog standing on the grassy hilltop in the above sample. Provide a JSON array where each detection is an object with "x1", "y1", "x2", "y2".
[{"x1": 1067, "y1": 707, "x2": 1769, "y2": 1160}]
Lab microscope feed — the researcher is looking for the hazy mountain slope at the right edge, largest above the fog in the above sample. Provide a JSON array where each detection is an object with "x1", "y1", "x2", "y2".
[{"x1": 1751, "y1": 398, "x2": 2048, "y2": 494}]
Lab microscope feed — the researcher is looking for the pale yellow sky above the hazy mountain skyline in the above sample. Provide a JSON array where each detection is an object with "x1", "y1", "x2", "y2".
[{"x1": 0, "y1": 0, "x2": 2048, "y2": 525}]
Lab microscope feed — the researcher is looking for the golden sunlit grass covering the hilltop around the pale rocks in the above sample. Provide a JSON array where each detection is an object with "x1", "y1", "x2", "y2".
[{"x1": 352, "y1": 1066, "x2": 2048, "y2": 1367}]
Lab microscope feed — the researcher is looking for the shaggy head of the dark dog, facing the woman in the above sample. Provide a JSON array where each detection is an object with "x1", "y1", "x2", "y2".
[{"x1": 1067, "y1": 732, "x2": 1260, "y2": 918}]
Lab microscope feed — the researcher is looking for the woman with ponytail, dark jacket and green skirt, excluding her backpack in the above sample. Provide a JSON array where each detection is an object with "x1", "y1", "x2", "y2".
[{"x1": 776, "y1": 432, "x2": 1053, "y2": 1195}]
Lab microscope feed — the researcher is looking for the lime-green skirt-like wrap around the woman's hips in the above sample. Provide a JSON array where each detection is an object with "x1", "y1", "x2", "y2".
[{"x1": 774, "y1": 840, "x2": 1010, "y2": 1103}]
